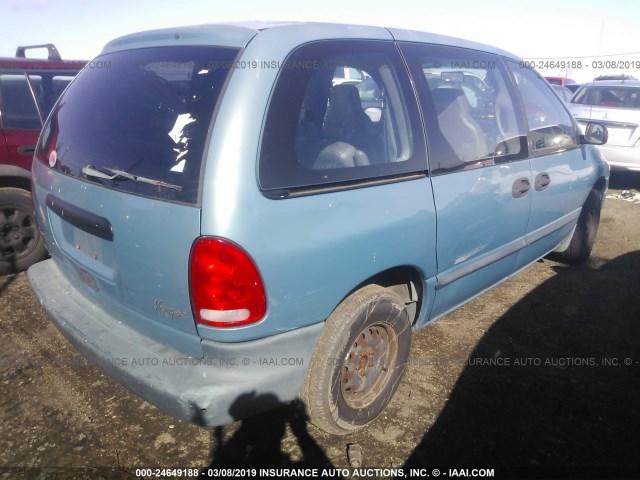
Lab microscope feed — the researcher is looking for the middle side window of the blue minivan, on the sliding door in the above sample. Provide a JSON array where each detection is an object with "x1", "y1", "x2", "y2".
[{"x1": 402, "y1": 43, "x2": 528, "y2": 175}]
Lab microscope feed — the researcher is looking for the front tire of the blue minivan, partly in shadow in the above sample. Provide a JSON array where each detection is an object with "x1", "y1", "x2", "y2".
[{"x1": 552, "y1": 190, "x2": 602, "y2": 265}]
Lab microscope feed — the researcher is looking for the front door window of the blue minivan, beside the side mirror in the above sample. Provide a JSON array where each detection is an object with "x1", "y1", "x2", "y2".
[{"x1": 508, "y1": 61, "x2": 578, "y2": 155}]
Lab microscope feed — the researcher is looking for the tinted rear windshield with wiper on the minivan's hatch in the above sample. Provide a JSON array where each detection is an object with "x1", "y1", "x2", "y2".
[{"x1": 38, "y1": 47, "x2": 238, "y2": 203}]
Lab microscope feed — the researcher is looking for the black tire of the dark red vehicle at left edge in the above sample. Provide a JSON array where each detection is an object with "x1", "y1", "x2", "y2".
[{"x1": 0, "y1": 188, "x2": 47, "y2": 275}]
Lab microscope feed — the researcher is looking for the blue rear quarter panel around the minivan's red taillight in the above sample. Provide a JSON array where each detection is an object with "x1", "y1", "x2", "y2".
[{"x1": 199, "y1": 24, "x2": 435, "y2": 341}]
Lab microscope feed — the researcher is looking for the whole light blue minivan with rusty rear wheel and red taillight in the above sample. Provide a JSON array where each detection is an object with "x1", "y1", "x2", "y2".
[{"x1": 29, "y1": 23, "x2": 609, "y2": 434}]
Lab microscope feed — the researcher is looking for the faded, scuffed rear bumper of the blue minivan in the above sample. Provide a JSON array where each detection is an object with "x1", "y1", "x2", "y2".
[{"x1": 28, "y1": 259, "x2": 323, "y2": 426}]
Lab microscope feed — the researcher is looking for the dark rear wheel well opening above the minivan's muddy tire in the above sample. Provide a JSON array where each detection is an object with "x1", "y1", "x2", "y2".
[{"x1": 345, "y1": 265, "x2": 423, "y2": 324}]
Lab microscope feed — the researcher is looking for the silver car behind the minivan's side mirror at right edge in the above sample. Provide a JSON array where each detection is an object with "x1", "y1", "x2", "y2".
[{"x1": 568, "y1": 79, "x2": 640, "y2": 172}]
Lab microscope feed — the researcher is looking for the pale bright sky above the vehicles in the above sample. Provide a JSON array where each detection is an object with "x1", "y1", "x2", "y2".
[{"x1": 0, "y1": 0, "x2": 640, "y2": 81}]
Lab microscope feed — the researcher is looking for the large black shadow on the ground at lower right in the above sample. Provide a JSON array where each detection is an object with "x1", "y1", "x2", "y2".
[{"x1": 405, "y1": 251, "x2": 640, "y2": 470}]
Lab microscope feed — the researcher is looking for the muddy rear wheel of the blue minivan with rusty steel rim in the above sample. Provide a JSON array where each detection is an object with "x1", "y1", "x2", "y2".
[{"x1": 300, "y1": 285, "x2": 411, "y2": 435}]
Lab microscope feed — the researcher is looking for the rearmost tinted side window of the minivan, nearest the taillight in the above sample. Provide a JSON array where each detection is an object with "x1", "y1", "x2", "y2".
[{"x1": 259, "y1": 41, "x2": 426, "y2": 191}]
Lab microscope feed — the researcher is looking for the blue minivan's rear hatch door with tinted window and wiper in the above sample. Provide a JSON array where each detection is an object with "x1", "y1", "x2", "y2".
[{"x1": 34, "y1": 47, "x2": 238, "y2": 355}]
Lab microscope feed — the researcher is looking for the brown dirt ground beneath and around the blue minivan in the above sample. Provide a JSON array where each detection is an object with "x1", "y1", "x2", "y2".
[{"x1": 0, "y1": 174, "x2": 640, "y2": 479}]
